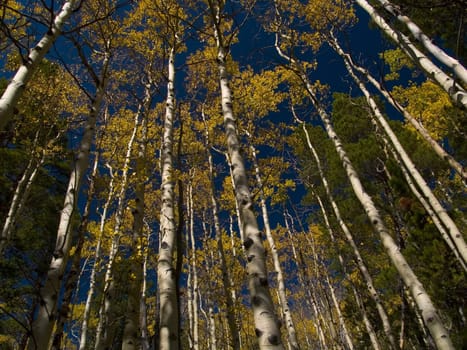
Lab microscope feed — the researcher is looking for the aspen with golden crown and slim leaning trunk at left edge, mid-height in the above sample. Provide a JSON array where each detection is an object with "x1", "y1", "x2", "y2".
[{"x1": 0, "y1": 60, "x2": 82, "y2": 252}]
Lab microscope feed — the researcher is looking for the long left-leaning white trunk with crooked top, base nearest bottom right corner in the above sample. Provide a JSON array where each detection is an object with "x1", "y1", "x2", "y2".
[{"x1": 276, "y1": 37, "x2": 453, "y2": 350}]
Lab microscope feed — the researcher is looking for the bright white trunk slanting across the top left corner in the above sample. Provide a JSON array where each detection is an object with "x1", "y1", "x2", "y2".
[{"x1": 0, "y1": 0, "x2": 78, "y2": 130}]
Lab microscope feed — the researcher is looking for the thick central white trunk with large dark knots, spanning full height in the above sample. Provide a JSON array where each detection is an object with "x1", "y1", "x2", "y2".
[{"x1": 208, "y1": 0, "x2": 283, "y2": 349}]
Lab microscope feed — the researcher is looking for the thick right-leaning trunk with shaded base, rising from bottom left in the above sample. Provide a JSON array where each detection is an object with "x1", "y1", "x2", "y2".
[{"x1": 28, "y1": 55, "x2": 109, "y2": 350}]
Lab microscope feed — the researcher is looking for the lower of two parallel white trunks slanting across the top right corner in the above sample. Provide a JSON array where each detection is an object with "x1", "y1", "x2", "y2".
[{"x1": 355, "y1": 0, "x2": 467, "y2": 108}]
